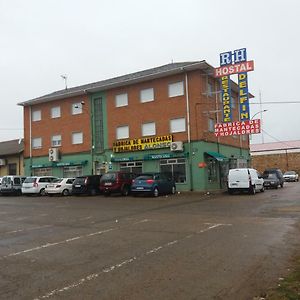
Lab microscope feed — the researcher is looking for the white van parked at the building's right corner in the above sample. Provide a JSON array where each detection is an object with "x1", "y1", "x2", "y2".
[{"x1": 227, "y1": 168, "x2": 265, "y2": 195}]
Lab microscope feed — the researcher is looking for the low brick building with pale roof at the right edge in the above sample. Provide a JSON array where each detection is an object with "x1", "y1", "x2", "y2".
[{"x1": 250, "y1": 141, "x2": 300, "y2": 173}]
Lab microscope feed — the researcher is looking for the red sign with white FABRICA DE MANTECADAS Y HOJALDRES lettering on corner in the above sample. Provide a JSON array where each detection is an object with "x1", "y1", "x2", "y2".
[{"x1": 215, "y1": 119, "x2": 261, "y2": 137}]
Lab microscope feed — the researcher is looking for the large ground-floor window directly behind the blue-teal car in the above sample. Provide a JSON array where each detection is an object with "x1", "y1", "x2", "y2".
[{"x1": 160, "y1": 158, "x2": 186, "y2": 183}]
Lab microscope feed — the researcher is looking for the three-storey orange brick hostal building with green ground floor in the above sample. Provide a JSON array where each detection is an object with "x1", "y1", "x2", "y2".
[{"x1": 19, "y1": 61, "x2": 249, "y2": 190}]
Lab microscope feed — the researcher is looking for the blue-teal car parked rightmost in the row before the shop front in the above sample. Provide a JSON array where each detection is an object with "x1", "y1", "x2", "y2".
[{"x1": 131, "y1": 173, "x2": 176, "y2": 197}]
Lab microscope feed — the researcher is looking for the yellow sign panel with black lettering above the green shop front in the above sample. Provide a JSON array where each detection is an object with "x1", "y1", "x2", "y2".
[{"x1": 113, "y1": 134, "x2": 173, "y2": 153}]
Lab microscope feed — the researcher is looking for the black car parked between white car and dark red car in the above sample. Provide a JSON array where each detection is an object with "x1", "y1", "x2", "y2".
[{"x1": 72, "y1": 175, "x2": 101, "y2": 196}]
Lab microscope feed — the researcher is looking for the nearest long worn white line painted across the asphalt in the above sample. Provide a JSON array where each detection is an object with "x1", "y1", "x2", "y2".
[{"x1": 34, "y1": 224, "x2": 231, "y2": 300}]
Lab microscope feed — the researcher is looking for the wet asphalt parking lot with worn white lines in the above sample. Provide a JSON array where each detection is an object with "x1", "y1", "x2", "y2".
[{"x1": 0, "y1": 183, "x2": 300, "y2": 300}]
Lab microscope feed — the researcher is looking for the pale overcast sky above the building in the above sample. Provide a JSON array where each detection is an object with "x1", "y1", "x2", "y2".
[{"x1": 0, "y1": 0, "x2": 300, "y2": 143}]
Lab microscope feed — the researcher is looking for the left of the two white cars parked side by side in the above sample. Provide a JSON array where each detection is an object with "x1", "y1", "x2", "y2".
[{"x1": 22, "y1": 176, "x2": 57, "y2": 196}]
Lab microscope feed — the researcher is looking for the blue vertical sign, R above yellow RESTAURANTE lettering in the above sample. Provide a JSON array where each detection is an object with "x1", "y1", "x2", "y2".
[{"x1": 220, "y1": 52, "x2": 232, "y2": 123}]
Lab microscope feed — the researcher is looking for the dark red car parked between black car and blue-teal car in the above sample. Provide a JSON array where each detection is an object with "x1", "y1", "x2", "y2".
[{"x1": 100, "y1": 171, "x2": 136, "y2": 196}]
